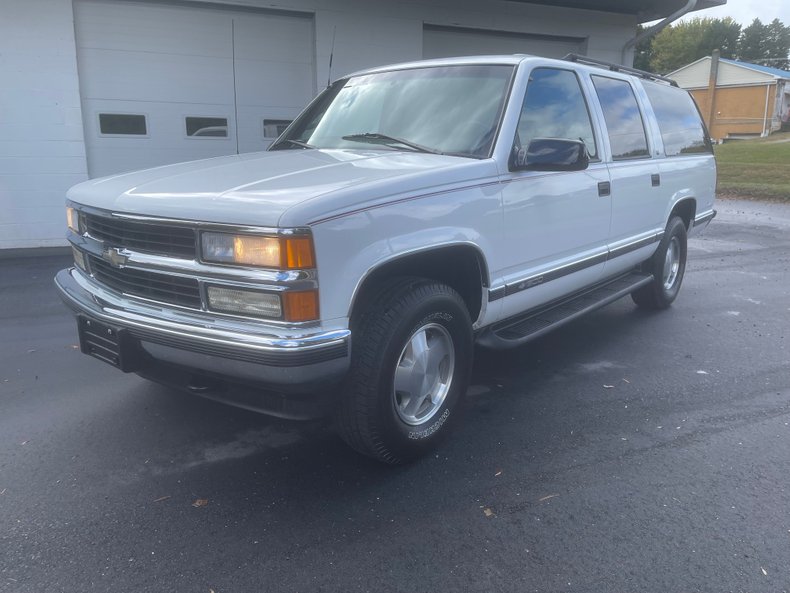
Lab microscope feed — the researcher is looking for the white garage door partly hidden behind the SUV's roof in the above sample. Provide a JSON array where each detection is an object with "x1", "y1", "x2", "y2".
[{"x1": 422, "y1": 25, "x2": 587, "y2": 58}]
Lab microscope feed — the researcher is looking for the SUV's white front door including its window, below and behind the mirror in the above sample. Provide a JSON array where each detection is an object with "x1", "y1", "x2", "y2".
[{"x1": 501, "y1": 68, "x2": 611, "y2": 317}]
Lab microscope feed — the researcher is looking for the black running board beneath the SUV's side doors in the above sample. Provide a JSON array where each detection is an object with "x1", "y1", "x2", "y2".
[{"x1": 477, "y1": 272, "x2": 653, "y2": 349}]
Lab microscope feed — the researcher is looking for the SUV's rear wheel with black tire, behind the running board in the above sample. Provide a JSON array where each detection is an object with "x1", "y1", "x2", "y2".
[{"x1": 631, "y1": 216, "x2": 688, "y2": 311}]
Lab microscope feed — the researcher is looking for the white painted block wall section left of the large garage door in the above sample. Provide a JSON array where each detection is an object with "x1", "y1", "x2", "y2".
[{"x1": 0, "y1": 0, "x2": 87, "y2": 249}]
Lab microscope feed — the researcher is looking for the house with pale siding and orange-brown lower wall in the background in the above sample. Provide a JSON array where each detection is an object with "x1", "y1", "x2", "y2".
[{"x1": 669, "y1": 55, "x2": 790, "y2": 140}]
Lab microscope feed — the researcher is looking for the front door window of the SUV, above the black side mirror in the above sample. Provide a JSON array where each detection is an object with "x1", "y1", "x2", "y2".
[{"x1": 515, "y1": 68, "x2": 598, "y2": 160}]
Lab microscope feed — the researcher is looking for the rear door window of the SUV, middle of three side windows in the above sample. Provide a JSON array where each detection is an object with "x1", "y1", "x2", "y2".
[{"x1": 592, "y1": 76, "x2": 650, "y2": 161}]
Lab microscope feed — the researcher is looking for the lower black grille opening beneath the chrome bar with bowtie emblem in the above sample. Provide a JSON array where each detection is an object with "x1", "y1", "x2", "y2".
[{"x1": 88, "y1": 256, "x2": 201, "y2": 309}]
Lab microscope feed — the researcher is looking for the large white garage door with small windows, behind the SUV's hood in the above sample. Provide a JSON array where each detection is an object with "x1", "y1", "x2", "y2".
[{"x1": 74, "y1": 0, "x2": 316, "y2": 177}]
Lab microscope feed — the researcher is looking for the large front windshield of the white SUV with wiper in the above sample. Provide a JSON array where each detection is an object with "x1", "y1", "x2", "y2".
[{"x1": 270, "y1": 65, "x2": 513, "y2": 158}]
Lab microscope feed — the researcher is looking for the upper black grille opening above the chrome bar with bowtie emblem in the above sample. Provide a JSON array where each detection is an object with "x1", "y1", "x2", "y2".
[{"x1": 85, "y1": 214, "x2": 197, "y2": 259}]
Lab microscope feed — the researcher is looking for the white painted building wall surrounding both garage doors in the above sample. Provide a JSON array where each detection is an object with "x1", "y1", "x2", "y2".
[{"x1": 0, "y1": 0, "x2": 637, "y2": 249}]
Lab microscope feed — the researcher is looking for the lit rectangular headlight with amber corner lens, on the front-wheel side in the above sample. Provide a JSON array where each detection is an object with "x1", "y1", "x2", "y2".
[{"x1": 201, "y1": 233, "x2": 315, "y2": 270}]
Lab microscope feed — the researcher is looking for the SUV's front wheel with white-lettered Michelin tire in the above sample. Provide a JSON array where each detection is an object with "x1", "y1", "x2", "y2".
[{"x1": 336, "y1": 278, "x2": 473, "y2": 464}]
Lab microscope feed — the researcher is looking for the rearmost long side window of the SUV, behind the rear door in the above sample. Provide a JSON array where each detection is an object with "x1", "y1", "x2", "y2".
[{"x1": 644, "y1": 83, "x2": 713, "y2": 156}]
